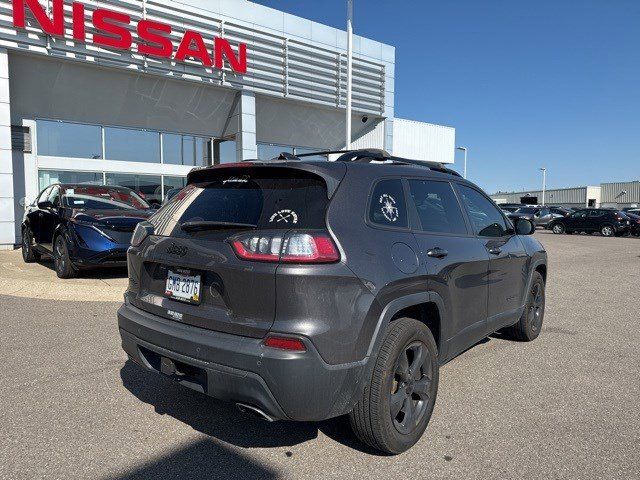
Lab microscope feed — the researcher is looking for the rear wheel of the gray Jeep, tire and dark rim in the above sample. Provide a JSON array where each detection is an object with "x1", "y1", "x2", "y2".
[{"x1": 349, "y1": 318, "x2": 439, "y2": 454}]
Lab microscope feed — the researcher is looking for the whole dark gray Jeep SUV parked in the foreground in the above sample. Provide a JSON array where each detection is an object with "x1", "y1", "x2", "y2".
[{"x1": 118, "y1": 150, "x2": 547, "y2": 453}]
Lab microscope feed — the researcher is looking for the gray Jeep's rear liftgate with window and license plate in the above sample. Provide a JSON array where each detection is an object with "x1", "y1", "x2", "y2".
[{"x1": 130, "y1": 164, "x2": 342, "y2": 337}]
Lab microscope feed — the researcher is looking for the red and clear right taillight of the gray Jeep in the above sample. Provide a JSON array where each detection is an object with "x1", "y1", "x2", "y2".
[{"x1": 231, "y1": 232, "x2": 340, "y2": 263}]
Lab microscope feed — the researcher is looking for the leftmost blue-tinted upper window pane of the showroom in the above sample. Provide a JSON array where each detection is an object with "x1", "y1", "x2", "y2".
[{"x1": 36, "y1": 120, "x2": 102, "y2": 158}]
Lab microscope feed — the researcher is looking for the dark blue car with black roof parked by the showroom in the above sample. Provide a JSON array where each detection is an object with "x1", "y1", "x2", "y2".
[{"x1": 22, "y1": 184, "x2": 154, "y2": 278}]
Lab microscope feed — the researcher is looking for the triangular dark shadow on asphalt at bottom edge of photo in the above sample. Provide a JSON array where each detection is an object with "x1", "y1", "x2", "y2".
[{"x1": 106, "y1": 439, "x2": 279, "y2": 480}]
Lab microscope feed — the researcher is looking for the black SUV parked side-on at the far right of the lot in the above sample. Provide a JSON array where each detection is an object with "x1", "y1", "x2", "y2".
[{"x1": 549, "y1": 208, "x2": 631, "y2": 237}]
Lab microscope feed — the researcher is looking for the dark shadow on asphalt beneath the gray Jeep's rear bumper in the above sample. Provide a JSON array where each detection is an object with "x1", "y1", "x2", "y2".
[{"x1": 120, "y1": 360, "x2": 380, "y2": 456}]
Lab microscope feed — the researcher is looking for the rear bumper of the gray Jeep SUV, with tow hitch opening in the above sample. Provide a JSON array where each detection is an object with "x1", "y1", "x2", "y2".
[{"x1": 118, "y1": 304, "x2": 366, "y2": 421}]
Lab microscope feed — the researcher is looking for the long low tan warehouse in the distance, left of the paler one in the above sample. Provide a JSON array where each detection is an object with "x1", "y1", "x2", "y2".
[{"x1": 491, "y1": 187, "x2": 601, "y2": 208}]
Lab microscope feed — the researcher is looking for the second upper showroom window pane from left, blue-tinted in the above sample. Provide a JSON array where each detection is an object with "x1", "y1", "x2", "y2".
[{"x1": 104, "y1": 127, "x2": 160, "y2": 163}]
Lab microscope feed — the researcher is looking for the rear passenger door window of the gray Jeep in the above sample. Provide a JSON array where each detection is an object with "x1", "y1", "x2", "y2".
[{"x1": 409, "y1": 180, "x2": 467, "y2": 234}]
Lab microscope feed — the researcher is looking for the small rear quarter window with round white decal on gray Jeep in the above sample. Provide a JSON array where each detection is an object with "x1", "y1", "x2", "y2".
[{"x1": 369, "y1": 178, "x2": 409, "y2": 228}]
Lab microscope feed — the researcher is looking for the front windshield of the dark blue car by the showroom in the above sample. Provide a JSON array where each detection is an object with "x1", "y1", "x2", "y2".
[{"x1": 63, "y1": 186, "x2": 150, "y2": 210}]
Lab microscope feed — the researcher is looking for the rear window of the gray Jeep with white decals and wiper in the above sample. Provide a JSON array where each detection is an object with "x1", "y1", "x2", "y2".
[{"x1": 154, "y1": 169, "x2": 328, "y2": 235}]
